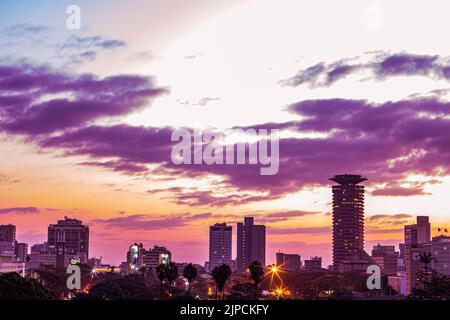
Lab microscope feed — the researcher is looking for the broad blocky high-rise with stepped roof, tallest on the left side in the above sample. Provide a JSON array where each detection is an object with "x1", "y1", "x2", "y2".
[{"x1": 48, "y1": 217, "x2": 89, "y2": 268}]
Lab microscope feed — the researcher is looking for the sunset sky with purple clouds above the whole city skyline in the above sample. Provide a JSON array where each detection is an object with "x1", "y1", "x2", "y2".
[{"x1": 0, "y1": 0, "x2": 450, "y2": 265}]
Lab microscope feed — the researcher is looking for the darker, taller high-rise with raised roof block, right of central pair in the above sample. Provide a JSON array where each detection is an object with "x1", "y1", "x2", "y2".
[{"x1": 236, "y1": 217, "x2": 266, "y2": 272}]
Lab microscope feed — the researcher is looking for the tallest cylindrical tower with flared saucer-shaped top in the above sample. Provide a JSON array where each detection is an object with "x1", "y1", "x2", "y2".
[{"x1": 330, "y1": 174, "x2": 367, "y2": 270}]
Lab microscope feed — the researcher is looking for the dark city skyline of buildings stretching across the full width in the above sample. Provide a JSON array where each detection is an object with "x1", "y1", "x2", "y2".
[{"x1": 0, "y1": 173, "x2": 450, "y2": 299}]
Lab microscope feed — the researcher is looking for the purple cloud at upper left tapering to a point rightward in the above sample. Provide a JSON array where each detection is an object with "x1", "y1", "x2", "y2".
[{"x1": 0, "y1": 65, "x2": 165, "y2": 134}]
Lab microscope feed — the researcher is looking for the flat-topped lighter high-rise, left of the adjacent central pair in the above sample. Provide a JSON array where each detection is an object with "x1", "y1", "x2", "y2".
[{"x1": 209, "y1": 223, "x2": 232, "y2": 270}]
